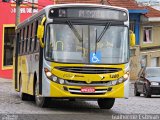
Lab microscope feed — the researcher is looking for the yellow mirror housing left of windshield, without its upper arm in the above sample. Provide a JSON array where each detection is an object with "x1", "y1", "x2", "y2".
[{"x1": 37, "y1": 25, "x2": 44, "y2": 48}]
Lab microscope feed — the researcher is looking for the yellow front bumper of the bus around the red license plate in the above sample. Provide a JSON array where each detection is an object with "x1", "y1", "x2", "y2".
[{"x1": 47, "y1": 80, "x2": 129, "y2": 99}]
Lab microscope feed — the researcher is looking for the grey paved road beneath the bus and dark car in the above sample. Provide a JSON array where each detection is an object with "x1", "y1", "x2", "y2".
[{"x1": 0, "y1": 79, "x2": 160, "y2": 120}]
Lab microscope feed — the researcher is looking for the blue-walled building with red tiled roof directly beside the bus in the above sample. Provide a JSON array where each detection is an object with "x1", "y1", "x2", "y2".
[{"x1": 107, "y1": 0, "x2": 149, "y2": 80}]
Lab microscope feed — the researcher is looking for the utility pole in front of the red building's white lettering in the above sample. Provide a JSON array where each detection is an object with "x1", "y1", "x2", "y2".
[{"x1": 16, "y1": 0, "x2": 23, "y2": 27}]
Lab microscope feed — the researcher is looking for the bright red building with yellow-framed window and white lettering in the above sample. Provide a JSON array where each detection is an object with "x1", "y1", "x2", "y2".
[{"x1": 0, "y1": 0, "x2": 53, "y2": 79}]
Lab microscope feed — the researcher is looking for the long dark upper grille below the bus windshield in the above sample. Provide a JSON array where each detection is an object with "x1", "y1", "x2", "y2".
[{"x1": 55, "y1": 67, "x2": 122, "y2": 74}]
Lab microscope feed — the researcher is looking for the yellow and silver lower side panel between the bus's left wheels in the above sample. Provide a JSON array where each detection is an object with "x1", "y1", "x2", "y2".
[{"x1": 21, "y1": 53, "x2": 39, "y2": 95}]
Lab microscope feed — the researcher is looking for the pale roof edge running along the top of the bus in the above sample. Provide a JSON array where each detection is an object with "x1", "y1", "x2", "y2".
[{"x1": 17, "y1": 3, "x2": 128, "y2": 29}]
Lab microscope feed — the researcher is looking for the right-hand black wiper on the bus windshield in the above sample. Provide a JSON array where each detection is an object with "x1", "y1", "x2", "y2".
[{"x1": 95, "y1": 23, "x2": 111, "y2": 53}]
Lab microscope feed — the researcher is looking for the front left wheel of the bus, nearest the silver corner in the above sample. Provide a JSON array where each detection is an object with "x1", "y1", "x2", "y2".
[{"x1": 34, "y1": 82, "x2": 49, "y2": 108}]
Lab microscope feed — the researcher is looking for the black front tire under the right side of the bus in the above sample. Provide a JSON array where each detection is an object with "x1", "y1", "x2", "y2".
[{"x1": 97, "y1": 98, "x2": 115, "y2": 109}]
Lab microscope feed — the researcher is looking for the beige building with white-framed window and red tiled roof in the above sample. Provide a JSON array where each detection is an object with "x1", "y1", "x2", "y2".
[{"x1": 140, "y1": 6, "x2": 160, "y2": 67}]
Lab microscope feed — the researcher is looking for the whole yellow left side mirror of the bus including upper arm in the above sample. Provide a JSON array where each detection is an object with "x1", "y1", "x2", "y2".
[{"x1": 37, "y1": 17, "x2": 46, "y2": 48}]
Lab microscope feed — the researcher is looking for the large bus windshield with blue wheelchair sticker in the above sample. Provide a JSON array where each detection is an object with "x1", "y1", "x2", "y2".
[{"x1": 45, "y1": 23, "x2": 129, "y2": 64}]
